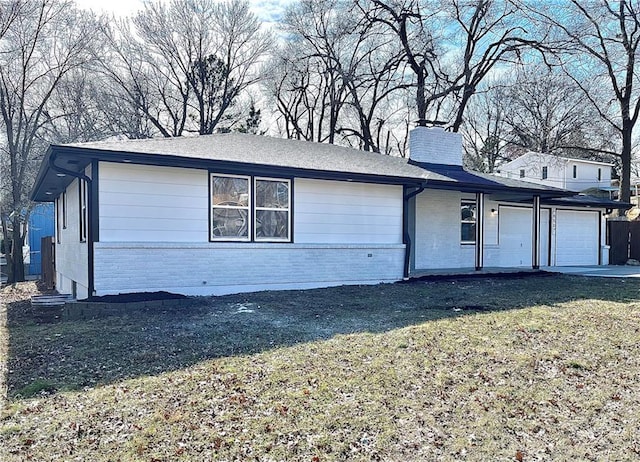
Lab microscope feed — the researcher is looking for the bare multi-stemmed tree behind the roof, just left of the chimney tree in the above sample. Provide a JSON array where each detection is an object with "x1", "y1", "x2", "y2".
[{"x1": 268, "y1": 0, "x2": 410, "y2": 152}]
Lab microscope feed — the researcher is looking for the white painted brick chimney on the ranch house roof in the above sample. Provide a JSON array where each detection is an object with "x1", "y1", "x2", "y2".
[{"x1": 409, "y1": 126, "x2": 462, "y2": 167}]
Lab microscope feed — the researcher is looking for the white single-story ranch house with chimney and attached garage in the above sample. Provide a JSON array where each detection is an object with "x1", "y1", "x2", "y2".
[{"x1": 32, "y1": 127, "x2": 616, "y2": 298}]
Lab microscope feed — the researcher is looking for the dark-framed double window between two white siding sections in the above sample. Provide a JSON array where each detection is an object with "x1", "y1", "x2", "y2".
[{"x1": 210, "y1": 174, "x2": 291, "y2": 242}]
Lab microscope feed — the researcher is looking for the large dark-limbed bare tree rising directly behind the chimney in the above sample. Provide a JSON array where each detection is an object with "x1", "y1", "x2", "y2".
[{"x1": 358, "y1": 0, "x2": 541, "y2": 131}]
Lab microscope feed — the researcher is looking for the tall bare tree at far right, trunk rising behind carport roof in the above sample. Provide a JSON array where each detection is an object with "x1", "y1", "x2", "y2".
[{"x1": 522, "y1": 0, "x2": 640, "y2": 202}]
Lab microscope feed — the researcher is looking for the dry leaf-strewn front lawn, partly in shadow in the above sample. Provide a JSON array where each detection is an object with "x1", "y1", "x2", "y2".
[{"x1": 0, "y1": 276, "x2": 640, "y2": 461}]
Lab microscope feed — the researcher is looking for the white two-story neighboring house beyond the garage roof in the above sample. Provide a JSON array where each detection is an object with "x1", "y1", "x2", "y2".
[{"x1": 497, "y1": 151, "x2": 613, "y2": 192}]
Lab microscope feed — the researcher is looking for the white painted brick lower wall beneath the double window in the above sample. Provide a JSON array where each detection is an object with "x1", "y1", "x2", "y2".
[{"x1": 95, "y1": 243, "x2": 404, "y2": 295}]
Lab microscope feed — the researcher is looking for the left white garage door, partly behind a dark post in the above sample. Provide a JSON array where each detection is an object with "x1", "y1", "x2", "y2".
[{"x1": 498, "y1": 207, "x2": 549, "y2": 267}]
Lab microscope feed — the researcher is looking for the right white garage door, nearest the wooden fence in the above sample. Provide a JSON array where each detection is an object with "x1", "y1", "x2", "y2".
[{"x1": 555, "y1": 210, "x2": 600, "y2": 266}]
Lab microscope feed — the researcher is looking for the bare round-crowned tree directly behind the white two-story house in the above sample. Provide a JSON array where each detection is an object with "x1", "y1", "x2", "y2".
[{"x1": 461, "y1": 63, "x2": 615, "y2": 171}]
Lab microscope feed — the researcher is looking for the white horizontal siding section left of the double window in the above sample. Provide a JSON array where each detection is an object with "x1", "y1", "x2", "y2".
[{"x1": 98, "y1": 162, "x2": 209, "y2": 242}]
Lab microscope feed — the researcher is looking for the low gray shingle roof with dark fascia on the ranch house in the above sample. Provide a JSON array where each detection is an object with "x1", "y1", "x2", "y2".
[{"x1": 32, "y1": 133, "x2": 580, "y2": 201}]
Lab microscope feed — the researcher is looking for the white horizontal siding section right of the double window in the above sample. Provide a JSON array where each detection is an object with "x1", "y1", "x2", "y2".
[{"x1": 293, "y1": 178, "x2": 402, "y2": 244}]
